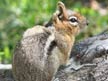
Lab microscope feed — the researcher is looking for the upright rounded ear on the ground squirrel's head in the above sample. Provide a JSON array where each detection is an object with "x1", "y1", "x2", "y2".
[{"x1": 58, "y1": 1, "x2": 68, "y2": 19}]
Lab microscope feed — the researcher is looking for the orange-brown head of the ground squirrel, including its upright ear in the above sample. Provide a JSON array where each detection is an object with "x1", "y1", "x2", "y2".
[{"x1": 52, "y1": 2, "x2": 88, "y2": 34}]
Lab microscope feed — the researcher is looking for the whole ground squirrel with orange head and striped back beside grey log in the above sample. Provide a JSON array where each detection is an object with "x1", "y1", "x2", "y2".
[{"x1": 12, "y1": 1, "x2": 88, "y2": 81}]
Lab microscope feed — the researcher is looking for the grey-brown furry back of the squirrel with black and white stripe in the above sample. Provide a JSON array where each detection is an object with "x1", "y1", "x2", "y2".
[{"x1": 13, "y1": 26, "x2": 60, "y2": 81}]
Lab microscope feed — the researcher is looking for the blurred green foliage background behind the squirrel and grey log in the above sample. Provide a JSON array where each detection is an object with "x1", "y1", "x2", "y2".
[{"x1": 0, "y1": 0, "x2": 108, "y2": 63}]
